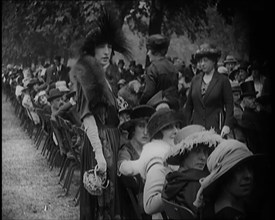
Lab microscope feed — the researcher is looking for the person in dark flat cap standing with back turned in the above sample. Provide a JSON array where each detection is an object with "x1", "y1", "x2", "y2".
[{"x1": 140, "y1": 34, "x2": 179, "y2": 109}]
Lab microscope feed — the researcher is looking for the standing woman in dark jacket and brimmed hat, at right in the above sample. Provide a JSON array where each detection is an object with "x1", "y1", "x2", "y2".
[{"x1": 184, "y1": 44, "x2": 233, "y2": 137}]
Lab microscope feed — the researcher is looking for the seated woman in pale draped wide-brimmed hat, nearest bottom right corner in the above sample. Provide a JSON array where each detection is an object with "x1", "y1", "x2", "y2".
[{"x1": 194, "y1": 139, "x2": 270, "y2": 220}]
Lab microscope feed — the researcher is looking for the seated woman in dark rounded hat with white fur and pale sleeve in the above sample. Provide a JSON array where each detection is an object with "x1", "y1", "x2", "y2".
[{"x1": 127, "y1": 108, "x2": 185, "y2": 219}]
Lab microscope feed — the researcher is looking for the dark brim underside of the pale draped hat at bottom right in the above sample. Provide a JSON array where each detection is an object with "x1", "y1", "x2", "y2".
[{"x1": 203, "y1": 154, "x2": 267, "y2": 196}]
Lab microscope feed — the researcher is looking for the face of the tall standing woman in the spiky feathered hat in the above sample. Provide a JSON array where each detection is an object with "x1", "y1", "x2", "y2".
[{"x1": 95, "y1": 43, "x2": 112, "y2": 66}]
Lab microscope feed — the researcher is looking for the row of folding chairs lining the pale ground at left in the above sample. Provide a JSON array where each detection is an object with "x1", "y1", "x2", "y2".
[{"x1": 4, "y1": 84, "x2": 85, "y2": 205}]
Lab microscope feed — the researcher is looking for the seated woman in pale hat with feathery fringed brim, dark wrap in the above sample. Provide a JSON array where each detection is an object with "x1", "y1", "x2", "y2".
[{"x1": 162, "y1": 125, "x2": 223, "y2": 216}]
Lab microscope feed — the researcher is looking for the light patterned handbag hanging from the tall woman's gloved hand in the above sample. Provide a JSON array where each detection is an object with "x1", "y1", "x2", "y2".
[{"x1": 83, "y1": 165, "x2": 109, "y2": 196}]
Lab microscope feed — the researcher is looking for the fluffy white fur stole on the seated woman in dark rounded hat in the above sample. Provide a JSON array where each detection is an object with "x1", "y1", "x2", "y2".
[{"x1": 129, "y1": 140, "x2": 174, "y2": 179}]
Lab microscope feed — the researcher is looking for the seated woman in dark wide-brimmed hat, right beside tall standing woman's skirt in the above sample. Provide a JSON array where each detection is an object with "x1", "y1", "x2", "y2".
[{"x1": 117, "y1": 105, "x2": 155, "y2": 219}]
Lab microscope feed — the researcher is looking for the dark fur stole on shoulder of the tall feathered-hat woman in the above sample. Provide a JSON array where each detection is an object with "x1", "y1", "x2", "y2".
[{"x1": 70, "y1": 55, "x2": 110, "y2": 109}]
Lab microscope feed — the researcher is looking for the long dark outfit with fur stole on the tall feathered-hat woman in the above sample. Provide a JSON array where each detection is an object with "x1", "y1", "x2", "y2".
[{"x1": 70, "y1": 55, "x2": 120, "y2": 220}]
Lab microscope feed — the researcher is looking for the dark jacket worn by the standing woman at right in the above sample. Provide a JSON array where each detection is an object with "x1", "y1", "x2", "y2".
[{"x1": 184, "y1": 71, "x2": 234, "y2": 132}]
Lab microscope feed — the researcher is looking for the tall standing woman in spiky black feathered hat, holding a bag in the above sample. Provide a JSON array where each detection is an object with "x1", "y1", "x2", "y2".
[{"x1": 70, "y1": 6, "x2": 133, "y2": 220}]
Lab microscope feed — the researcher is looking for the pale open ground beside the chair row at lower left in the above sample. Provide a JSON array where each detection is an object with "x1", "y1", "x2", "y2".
[{"x1": 2, "y1": 94, "x2": 79, "y2": 220}]
